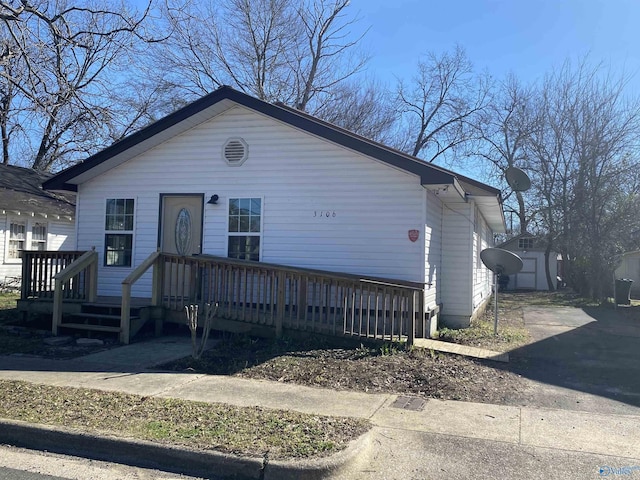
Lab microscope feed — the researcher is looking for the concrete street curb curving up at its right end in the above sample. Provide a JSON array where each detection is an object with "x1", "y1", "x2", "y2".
[{"x1": 0, "y1": 418, "x2": 370, "y2": 480}]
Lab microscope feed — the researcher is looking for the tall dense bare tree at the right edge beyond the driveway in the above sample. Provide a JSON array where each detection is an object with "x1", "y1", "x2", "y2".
[{"x1": 531, "y1": 60, "x2": 640, "y2": 299}]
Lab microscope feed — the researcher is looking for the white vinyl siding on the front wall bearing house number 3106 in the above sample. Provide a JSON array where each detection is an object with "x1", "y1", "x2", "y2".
[{"x1": 77, "y1": 107, "x2": 425, "y2": 296}]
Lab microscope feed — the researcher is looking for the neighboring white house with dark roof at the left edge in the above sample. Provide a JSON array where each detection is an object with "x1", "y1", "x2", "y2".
[{"x1": 0, "y1": 165, "x2": 75, "y2": 287}]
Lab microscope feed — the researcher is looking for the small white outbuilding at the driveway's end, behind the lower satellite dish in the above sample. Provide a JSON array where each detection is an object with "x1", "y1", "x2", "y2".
[{"x1": 498, "y1": 233, "x2": 558, "y2": 290}]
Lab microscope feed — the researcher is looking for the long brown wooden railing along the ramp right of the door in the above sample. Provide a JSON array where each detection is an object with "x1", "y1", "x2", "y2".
[{"x1": 154, "y1": 254, "x2": 425, "y2": 342}]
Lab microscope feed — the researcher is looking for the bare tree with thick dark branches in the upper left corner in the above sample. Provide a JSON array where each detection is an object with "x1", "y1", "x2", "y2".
[{"x1": 0, "y1": 0, "x2": 155, "y2": 170}]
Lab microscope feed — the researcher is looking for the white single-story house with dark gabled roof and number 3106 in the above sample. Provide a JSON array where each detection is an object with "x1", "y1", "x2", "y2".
[{"x1": 45, "y1": 87, "x2": 505, "y2": 328}]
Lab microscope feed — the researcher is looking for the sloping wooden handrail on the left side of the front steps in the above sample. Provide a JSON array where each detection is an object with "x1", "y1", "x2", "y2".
[{"x1": 51, "y1": 250, "x2": 98, "y2": 335}]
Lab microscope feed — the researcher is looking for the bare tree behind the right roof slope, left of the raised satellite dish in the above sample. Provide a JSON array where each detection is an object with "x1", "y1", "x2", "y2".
[{"x1": 397, "y1": 46, "x2": 490, "y2": 162}]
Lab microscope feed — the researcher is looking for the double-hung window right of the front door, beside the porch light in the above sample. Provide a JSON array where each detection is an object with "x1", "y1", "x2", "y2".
[{"x1": 227, "y1": 198, "x2": 262, "y2": 262}]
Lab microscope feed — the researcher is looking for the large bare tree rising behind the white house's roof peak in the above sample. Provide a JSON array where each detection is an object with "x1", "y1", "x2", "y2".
[{"x1": 149, "y1": 0, "x2": 390, "y2": 137}]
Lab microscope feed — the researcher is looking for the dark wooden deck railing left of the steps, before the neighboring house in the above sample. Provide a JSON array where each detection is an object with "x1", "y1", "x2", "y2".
[{"x1": 20, "y1": 250, "x2": 86, "y2": 300}]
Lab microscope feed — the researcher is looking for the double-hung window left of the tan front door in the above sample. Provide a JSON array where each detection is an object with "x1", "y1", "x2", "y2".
[{"x1": 104, "y1": 198, "x2": 134, "y2": 267}]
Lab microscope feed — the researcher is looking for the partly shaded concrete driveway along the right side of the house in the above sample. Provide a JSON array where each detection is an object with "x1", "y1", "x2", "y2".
[{"x1": 507, "y1": 306, "x2": 640, "y2": 414}]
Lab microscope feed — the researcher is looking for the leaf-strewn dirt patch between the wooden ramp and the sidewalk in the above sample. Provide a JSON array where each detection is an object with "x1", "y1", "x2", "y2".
[{"x1": 161, "y1": 336, "x2": 524, "y2": 403}]
